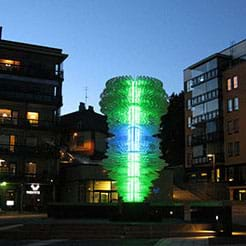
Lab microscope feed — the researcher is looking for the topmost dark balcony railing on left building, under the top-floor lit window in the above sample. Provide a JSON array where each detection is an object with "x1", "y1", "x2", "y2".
[{"x1": 0, "y1": 63, "x2": 63, "y2": 80}]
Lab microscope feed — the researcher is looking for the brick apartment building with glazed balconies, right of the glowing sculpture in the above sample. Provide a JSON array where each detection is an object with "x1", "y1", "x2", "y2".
[{"x1": 184, "y1": 40, "x2": 246, "y2": 200}]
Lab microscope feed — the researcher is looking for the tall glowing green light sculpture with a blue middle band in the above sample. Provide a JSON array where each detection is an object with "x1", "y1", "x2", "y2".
[{"x1": 100, "y1": 76, "x2": 167, "y2": 202}]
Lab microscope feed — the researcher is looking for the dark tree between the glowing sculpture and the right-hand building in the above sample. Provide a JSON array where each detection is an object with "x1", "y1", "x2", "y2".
[{"x1": 160, "y1": 91, "x2": 185, "y2": 166}]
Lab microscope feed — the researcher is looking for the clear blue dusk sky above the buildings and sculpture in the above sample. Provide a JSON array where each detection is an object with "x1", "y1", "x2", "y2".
[{"x1": 0, "y1": 0, "x2": 246, "y2": 113}]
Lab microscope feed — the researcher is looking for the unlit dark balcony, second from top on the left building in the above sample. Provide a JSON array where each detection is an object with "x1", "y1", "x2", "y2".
[{"x1": 0, "y1": 89, "x2": 62, "y2": 105}]
